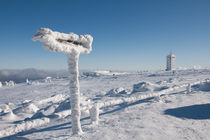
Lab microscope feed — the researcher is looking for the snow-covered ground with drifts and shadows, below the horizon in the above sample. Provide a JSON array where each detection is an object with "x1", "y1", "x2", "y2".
[{"x1": 0, "y1": 70, "x2": 210, "y2": 140}]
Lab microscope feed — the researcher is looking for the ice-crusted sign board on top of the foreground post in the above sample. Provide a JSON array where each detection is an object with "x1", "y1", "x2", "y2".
[{"x1": 32, "y1": 28, "x2": 93, "y2": 54}]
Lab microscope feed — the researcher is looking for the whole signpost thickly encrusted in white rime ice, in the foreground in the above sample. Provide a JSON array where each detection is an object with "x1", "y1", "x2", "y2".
[{"x1": 32, "y1": 28, "x2": 93, "y2": 134}]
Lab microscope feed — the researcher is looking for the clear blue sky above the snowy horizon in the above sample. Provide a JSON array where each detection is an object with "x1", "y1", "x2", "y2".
[{"x1": 0, "y1": 0, "x2": 210, "y2": 70}]
